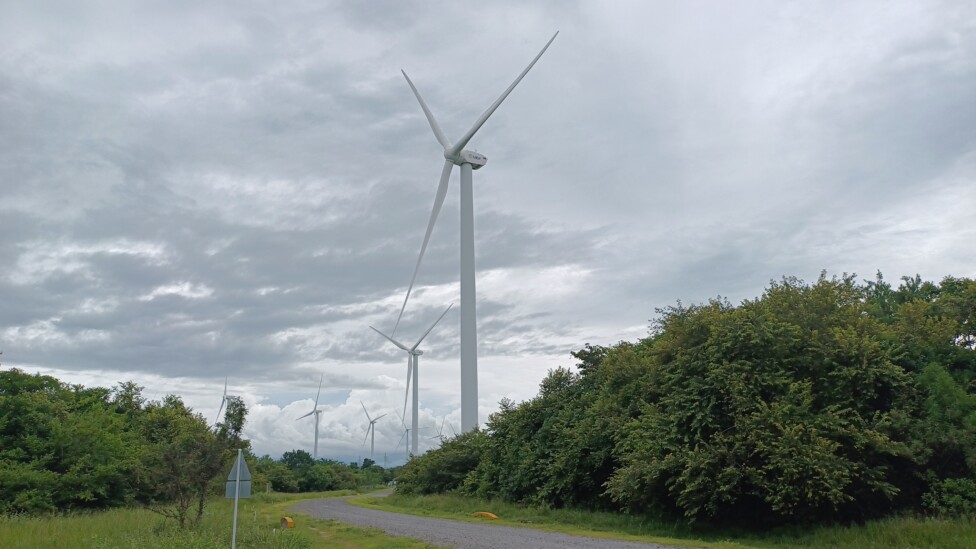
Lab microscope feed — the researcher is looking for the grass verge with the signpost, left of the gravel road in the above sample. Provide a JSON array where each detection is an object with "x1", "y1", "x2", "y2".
[{"x1": 0, "y1": 492, "x2": 442, "y2": 549}]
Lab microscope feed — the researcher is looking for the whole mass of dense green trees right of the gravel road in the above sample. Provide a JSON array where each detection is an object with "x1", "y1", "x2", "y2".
[{"x1": 398, "y1": 273, "x2": 976, "y2": 525}]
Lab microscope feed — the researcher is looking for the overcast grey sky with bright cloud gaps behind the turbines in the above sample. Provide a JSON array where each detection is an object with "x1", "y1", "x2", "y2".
[{"x1": 0, "y1": 0, "x2": 976, "y2": 465}]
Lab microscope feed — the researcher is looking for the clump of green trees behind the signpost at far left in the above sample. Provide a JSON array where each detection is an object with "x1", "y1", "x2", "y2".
[{"x1": 0, "y1": 369, "x2": 249, "y2": 526}]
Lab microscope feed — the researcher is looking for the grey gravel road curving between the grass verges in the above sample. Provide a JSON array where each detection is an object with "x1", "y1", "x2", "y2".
[{"x1": 291, "y1": 498, "x2": 679, "y2": 549}]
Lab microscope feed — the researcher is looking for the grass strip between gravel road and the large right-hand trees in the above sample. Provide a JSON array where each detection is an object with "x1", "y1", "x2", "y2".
[{"x1": 362, "y1": 495, "x2": 976, "y2": 549}]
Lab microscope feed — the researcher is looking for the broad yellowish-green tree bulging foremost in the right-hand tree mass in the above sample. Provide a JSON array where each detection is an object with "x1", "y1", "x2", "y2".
[{"x1": 609, "y1": 276, "x2": 911, "y2": 518}]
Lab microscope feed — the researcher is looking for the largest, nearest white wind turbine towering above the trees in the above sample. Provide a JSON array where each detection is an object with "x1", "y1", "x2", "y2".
[{"x1": 393, "y1": 32, "x2": 559, "y2": 432}]
